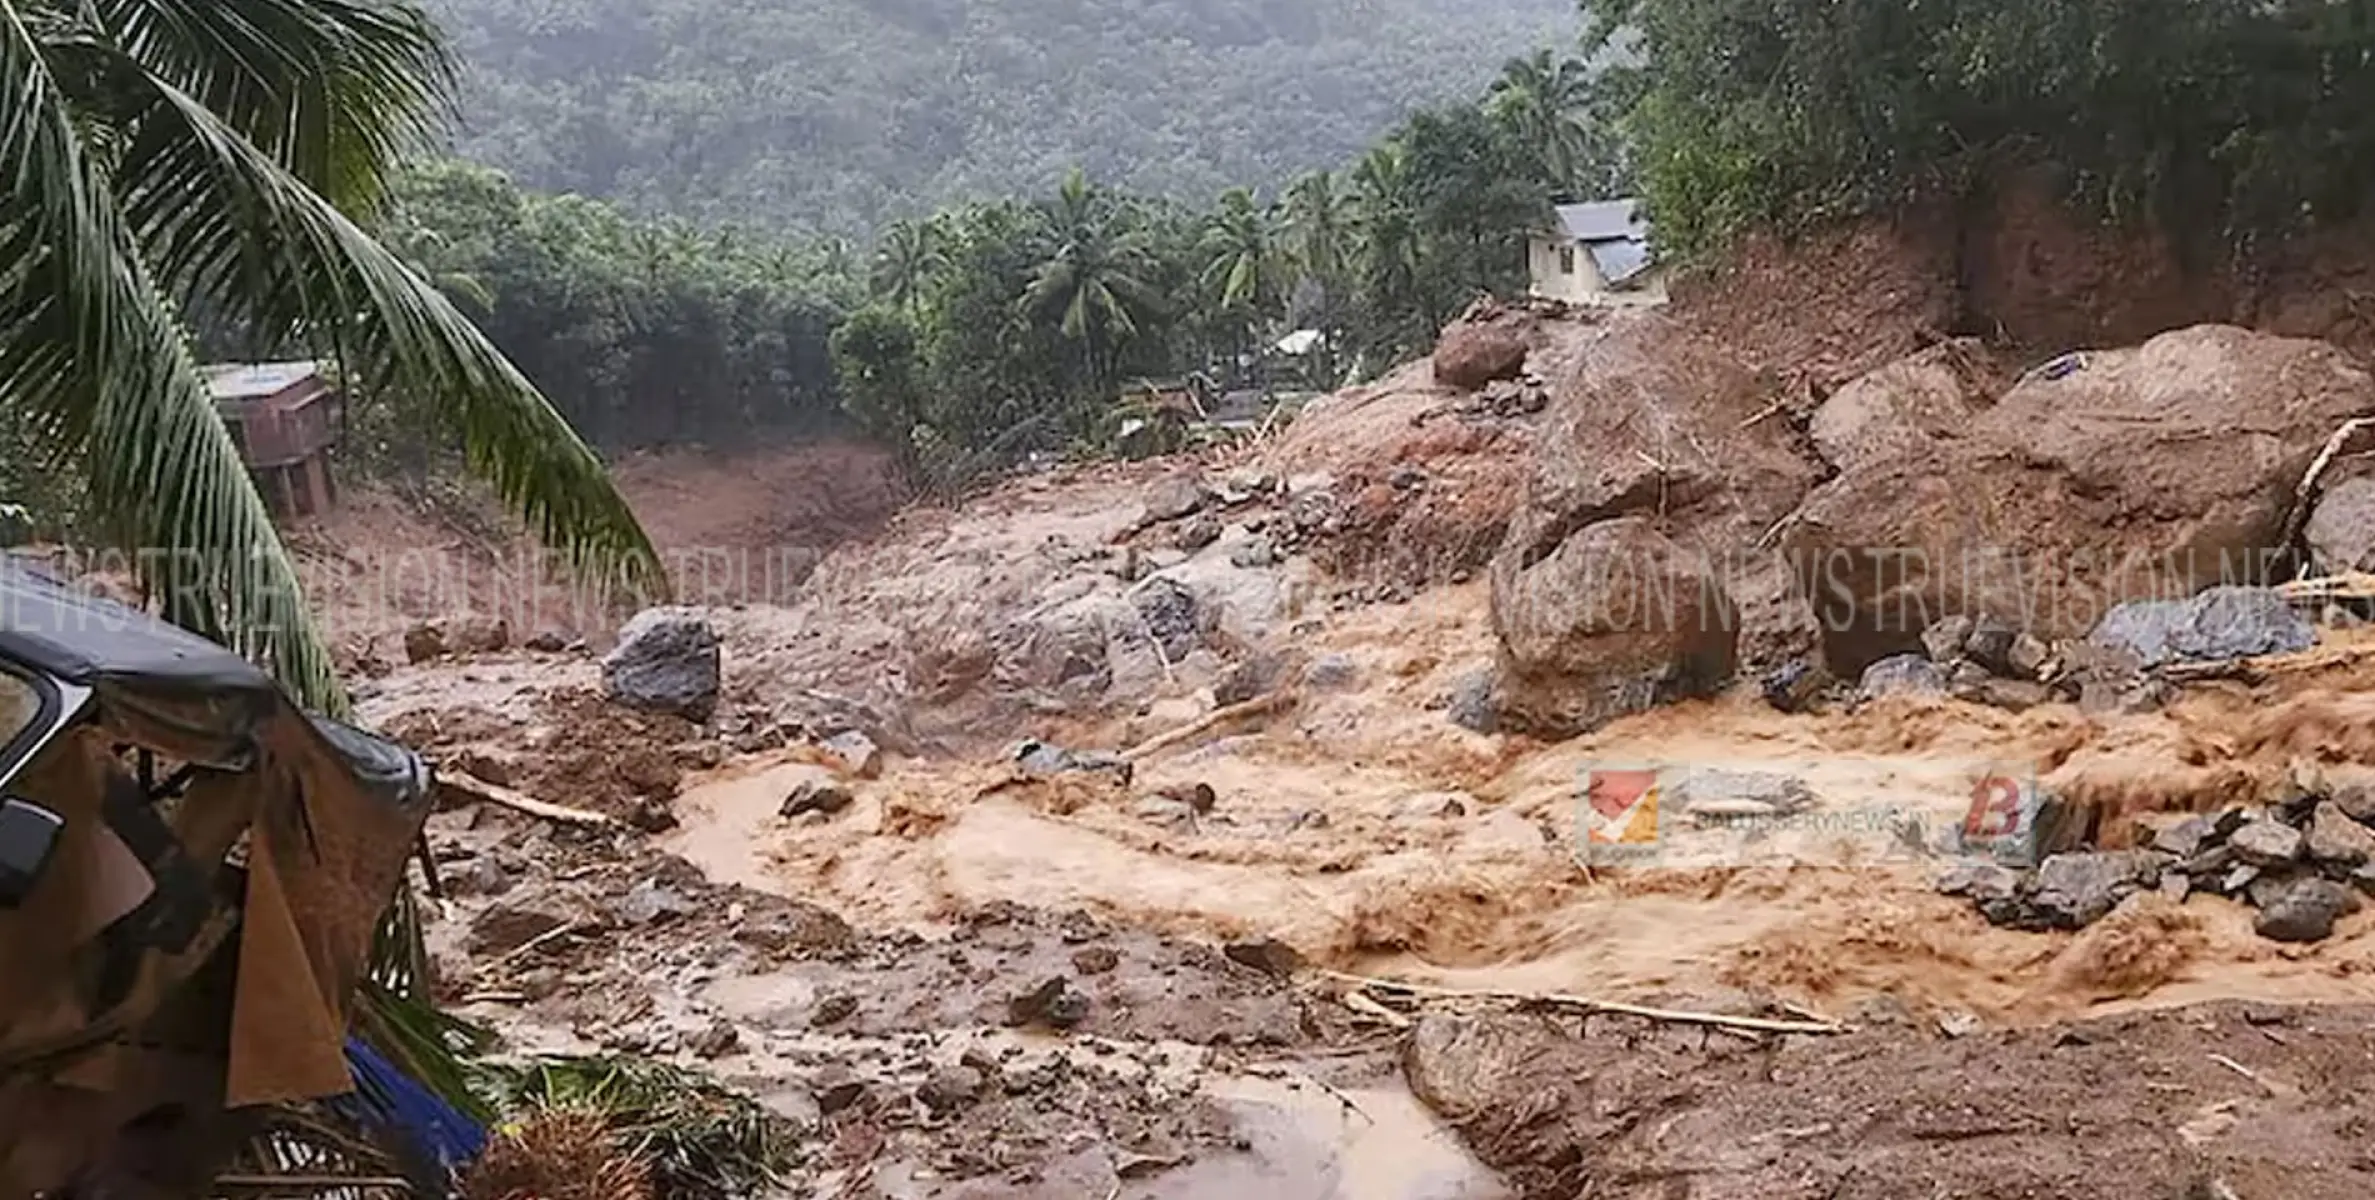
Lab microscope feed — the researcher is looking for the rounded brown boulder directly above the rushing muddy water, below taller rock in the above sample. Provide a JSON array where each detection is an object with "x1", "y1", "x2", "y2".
[{"x1": 1492, "y1": 516, "x2": 1739, "y2": 734}]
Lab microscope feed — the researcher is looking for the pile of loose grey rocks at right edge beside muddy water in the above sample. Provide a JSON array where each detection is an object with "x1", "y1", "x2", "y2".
[{"x1": 1938, "y1": 772, "x2": 2375, "y2": 941}]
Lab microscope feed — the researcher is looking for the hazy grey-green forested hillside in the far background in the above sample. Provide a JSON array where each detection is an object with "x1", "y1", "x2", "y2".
[{"x1": 430, "y1": 0, "x2": 1577, "y2": 235}]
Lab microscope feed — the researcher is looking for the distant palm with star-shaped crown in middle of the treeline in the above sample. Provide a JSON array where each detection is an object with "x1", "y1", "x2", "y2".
[{"x1": 1021, "y1": 166, "x2": 1154, "y2": 397}]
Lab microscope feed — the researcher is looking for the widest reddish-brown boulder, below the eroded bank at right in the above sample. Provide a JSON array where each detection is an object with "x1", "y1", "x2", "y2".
[{"x1": 1781, "y1": 326, "x2": 2375, "y2": 661}]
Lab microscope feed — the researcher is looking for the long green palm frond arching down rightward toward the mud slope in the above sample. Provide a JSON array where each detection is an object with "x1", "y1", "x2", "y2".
[{"x1": 103, "y1": 57, "x2": 667, "y2": 592}]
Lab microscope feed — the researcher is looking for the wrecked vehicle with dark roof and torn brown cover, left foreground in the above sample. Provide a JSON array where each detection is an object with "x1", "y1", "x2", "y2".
[{"x1": 0, "y1": 563, "x2": 432, "y2": 1200}]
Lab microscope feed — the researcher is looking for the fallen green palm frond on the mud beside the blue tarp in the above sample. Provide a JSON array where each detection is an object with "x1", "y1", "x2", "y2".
[{"x1": 470, "y1": 1057, "x2": 793, "y2": 1200}]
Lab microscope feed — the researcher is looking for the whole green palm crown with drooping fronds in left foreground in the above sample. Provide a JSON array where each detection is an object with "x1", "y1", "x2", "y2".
[{"x1": 0, "y1": 0, "x2": 665, "y2": 713}]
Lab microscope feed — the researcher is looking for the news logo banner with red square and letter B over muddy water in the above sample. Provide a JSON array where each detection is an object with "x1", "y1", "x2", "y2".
[{"x1": 1575, "y1": 758, "x2": 2043, "y2": 867}]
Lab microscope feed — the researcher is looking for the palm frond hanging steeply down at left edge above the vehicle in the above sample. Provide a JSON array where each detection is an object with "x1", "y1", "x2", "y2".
[{"x1": 0, "y1": 0, "x2": 347, "y2": 713}]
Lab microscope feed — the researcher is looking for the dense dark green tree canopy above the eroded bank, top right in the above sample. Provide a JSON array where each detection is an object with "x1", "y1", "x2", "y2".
[{"x1": 1591, "y1": 0, "x2": 2375, "y2": 250}]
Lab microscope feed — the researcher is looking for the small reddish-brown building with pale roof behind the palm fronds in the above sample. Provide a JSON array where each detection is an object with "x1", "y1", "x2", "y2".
[{"x1": 207, "y1": 364, "x2": 342, "y2": 516}]
